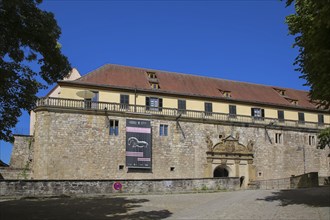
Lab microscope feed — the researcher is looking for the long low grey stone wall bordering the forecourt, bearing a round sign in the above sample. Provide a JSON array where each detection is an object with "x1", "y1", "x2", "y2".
[{"x1": 0, "y1": 177, "x2": 240, "y2": 197}]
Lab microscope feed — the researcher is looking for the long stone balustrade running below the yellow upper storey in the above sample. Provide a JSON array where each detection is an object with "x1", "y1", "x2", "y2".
[{"x1": 36, "y1": 97, "x2": 330, "y2": 129}]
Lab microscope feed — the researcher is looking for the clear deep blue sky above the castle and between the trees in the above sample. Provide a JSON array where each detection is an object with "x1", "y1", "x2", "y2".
[{"x1": 0, "y1": 0, "x2": 308, "y2": 163}]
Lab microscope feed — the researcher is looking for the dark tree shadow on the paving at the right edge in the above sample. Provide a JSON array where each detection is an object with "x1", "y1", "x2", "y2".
[{"x1": 257, "y1": 186, "x2": 330, "y2": 207}]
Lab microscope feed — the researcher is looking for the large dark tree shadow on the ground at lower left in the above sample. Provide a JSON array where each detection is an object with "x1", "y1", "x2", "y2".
[{"x1": 0, "y1": 197, "x2": 172, "y2": 220}]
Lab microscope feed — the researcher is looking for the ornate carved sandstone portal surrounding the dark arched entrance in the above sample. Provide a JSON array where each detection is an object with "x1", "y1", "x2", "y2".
[{"x1": 206, "y1": 135, "x2": 255, "y2": 186}]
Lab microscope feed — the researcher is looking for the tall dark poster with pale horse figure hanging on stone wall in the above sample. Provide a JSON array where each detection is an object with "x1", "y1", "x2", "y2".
[{"x1": 126, "y1": 119, "x2": 152, "y2": 169}]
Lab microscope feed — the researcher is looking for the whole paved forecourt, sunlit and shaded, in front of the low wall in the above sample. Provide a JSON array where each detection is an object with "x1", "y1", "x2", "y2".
[{"x1": 0, "y1": 187, "x2": 330, "y2": 220}]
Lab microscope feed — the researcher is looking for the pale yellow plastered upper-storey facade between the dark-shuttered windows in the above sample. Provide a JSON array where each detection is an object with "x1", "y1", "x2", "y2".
[{"x1": 59, "y1": 86, "x2": 330, "y2": 123}]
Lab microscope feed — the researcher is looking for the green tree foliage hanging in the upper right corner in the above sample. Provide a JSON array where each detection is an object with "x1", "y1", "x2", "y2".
[{"x1": 286, "y1": 0, "x2": 330, "y2": 109}]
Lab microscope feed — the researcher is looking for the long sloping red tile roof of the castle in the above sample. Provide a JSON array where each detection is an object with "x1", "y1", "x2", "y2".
[{"x1": 74, "y1": 64, "x2": 316, "y2": 109}]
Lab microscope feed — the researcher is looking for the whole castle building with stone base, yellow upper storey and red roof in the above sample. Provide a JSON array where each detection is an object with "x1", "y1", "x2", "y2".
[{"x1": 5, "y1": 64, "x2": 330, "y2": 185}]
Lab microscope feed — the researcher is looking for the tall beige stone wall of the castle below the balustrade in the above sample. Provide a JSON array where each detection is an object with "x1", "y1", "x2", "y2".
[{"x1": 13, "y1": 110, "x2": 330, "y2": 181}]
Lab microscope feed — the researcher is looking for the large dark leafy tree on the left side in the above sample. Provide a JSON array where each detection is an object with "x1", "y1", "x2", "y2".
[{"x1": 0, "y1": 0, "x2": 71, "y2": 141}]
